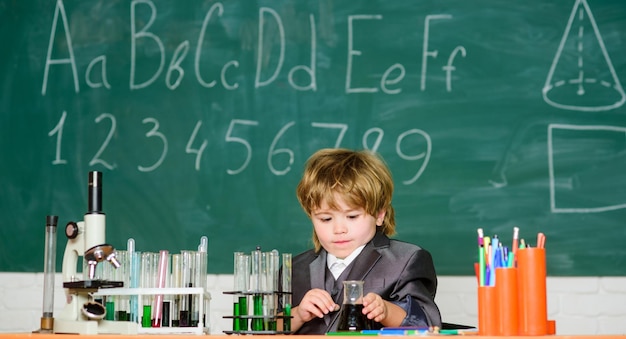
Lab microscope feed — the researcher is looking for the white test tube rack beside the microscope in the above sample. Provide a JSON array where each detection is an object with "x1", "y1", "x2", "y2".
[{"x1": 93, "y1": 287, "x2": 211, "y2": 334}]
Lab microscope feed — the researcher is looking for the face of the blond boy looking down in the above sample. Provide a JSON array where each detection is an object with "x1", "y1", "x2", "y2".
[{"x1": 311, "y1": 194, "x2": 385, "y2": 259}]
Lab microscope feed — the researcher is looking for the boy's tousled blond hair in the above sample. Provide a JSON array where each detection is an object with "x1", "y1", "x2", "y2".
[{"x1": 296, "y1": 149, "x2": 396, "y2": 252}]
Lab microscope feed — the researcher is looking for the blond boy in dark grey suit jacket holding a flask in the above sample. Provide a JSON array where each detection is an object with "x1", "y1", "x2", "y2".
[{"x1": 291, "y1": 149, "x2": 441, "y2": 334}]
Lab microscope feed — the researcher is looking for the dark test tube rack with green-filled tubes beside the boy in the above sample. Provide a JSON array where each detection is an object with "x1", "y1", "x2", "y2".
[{"x1": 223, "y1": 291, "x2": 293, "y2": 334}]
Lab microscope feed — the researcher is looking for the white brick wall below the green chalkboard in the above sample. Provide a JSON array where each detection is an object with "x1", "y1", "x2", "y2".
[{"x1": 0, "y1": 273, "x2": 626, "y2": 335}]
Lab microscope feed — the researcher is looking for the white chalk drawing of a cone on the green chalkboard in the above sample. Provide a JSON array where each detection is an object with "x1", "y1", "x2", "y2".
[{"x1": 542, "y1": 0, "x2": 626, "y2": 112}]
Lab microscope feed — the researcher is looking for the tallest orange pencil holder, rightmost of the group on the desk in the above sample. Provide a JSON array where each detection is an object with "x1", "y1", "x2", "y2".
[{"x1": 516, "y1": 248, "x2": 548, "y2": 335}]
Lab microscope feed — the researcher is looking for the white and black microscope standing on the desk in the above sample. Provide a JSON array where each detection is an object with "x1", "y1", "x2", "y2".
[{"x1": 54, "y1": 171, "x2": 137, "y2": 334}]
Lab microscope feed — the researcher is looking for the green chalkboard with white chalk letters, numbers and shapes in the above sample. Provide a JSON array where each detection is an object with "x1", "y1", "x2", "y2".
[{"x1": 0, "y1": 0, "x2": 626, "y2": 276}]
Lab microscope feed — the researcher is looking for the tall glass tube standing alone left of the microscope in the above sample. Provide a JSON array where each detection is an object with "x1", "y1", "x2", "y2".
[{"x1": 40, "y1": 215, "x2": 59, "y2": 332}]
